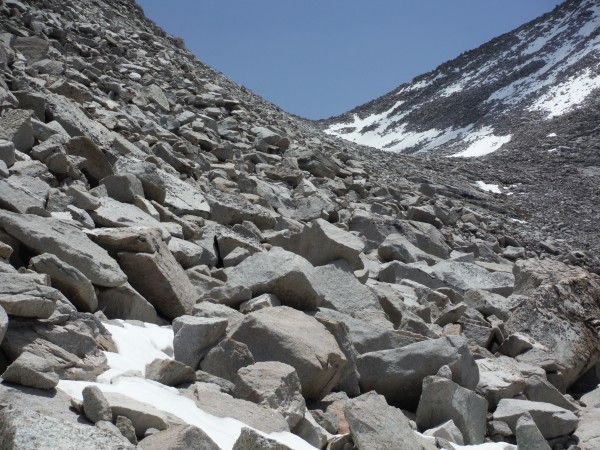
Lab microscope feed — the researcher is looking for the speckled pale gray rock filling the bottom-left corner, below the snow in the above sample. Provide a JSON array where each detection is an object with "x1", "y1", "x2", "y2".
[{"x1": 0, "y1": 405, "x2": 135, "y2": 450}]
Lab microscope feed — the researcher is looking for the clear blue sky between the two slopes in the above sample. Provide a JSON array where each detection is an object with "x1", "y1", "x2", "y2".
[{"x1": 137, "y1": 0, "x2": 560, "y2": 119}]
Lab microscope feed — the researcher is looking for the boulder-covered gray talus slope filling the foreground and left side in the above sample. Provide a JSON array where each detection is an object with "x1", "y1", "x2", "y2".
[{"x1": 0, "y1": 0, "x2": 600, "y2": 450}]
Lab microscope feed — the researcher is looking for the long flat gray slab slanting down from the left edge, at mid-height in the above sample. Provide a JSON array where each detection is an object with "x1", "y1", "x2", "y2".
[{"x1": 0, "y1": 212, "x2": 127, "y2": 287}]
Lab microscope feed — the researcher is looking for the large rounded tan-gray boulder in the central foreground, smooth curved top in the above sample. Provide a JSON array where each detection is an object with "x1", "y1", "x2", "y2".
[{"x1": 231, "y1": 306, "x2": 347, "y2": 400}]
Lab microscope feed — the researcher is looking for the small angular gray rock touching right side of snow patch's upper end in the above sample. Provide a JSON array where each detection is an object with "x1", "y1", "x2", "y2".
[{"x1": 173, "y1": 316, "x2": 227, "y2": 370}]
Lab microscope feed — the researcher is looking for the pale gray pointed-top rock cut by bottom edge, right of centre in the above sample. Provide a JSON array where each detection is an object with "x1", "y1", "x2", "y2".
[{"x1": 344, "y1": 392, "x2": 436, "y2": 450}]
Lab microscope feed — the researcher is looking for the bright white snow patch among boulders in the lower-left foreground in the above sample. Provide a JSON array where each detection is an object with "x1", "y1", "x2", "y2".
[{"x1": 57, "y1": 323, "x2": 314, "y2": 450}]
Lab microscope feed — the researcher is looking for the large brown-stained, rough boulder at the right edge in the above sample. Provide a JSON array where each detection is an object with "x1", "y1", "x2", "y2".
[{"x1": 506, "y1": 260, "x2": 600, "y2": 392}]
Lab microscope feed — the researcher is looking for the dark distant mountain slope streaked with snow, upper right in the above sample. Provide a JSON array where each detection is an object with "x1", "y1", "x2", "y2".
[{"x1": 321, "y1": 0, "x2": 600, "y2": 156}]
